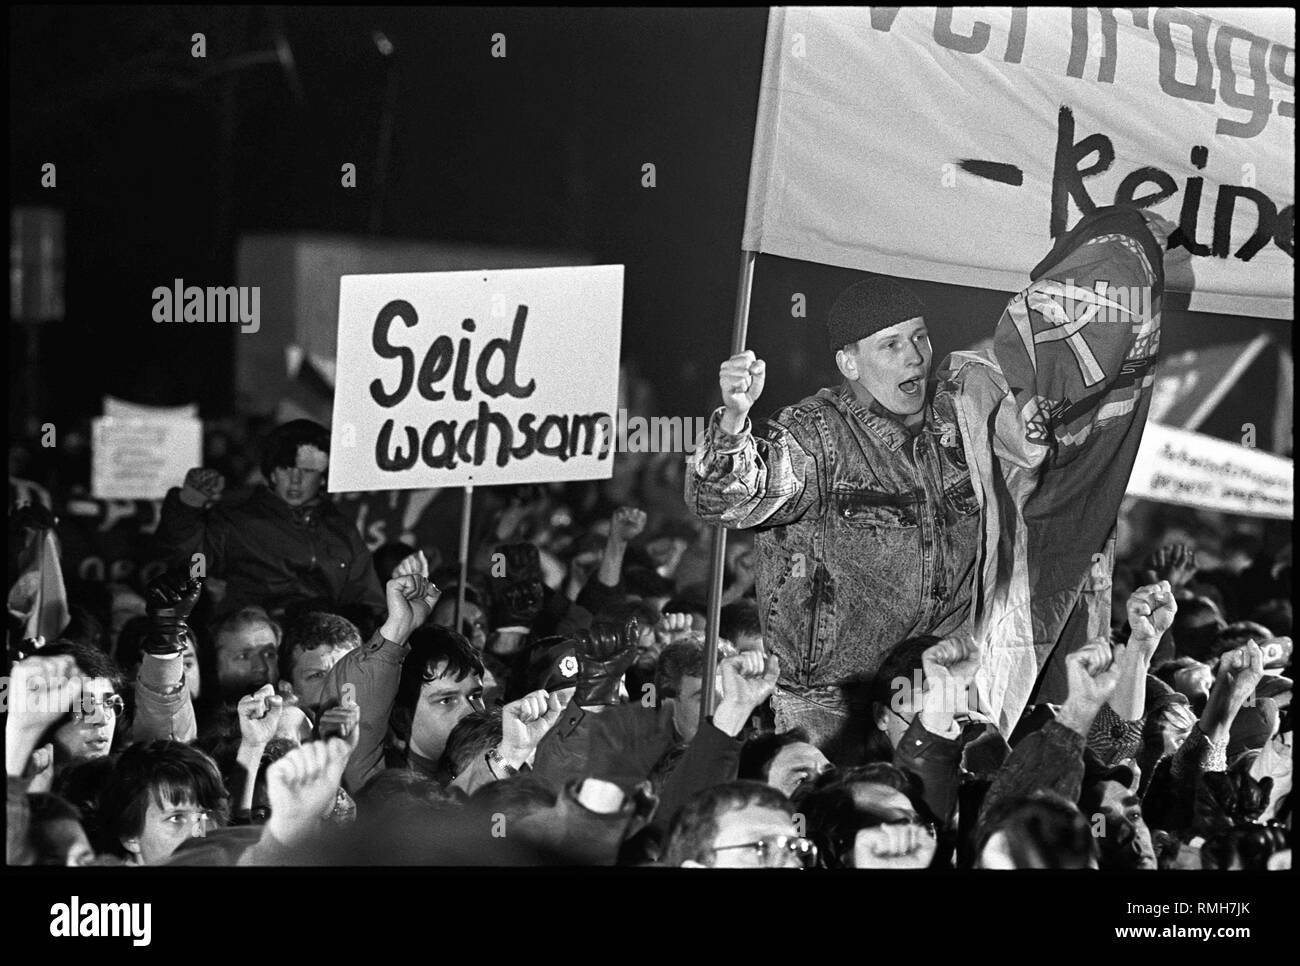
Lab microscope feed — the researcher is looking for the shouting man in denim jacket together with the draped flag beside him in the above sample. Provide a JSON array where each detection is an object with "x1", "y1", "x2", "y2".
[{"x1": 686, "y1": 207, "x2": 1186, "y2": 763}]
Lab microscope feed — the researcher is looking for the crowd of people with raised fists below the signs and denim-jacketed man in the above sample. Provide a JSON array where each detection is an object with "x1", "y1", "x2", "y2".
[{"x1": 5, "y1": 410, "x2": 1292, "y2": 870}]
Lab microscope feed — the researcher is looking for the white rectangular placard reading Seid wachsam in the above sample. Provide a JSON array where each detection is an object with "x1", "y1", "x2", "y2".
[{"x1": 329, "y1": 265, "x2": 623, "y2": 493}]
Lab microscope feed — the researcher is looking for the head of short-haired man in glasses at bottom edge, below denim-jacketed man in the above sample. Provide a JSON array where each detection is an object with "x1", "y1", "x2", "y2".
[{"x1": 662, "y1": 781, "x2": 816, "y2": 868}]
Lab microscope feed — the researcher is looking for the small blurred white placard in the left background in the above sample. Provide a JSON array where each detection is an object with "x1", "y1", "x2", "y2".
[{"x1": 91, "y1": 416, "x2": 203, "y2": 499}]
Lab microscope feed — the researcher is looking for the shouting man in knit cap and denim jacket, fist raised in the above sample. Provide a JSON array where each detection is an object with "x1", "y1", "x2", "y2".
[{"x1": 686, "y1": 277, "x2": 980, "y2": 758}]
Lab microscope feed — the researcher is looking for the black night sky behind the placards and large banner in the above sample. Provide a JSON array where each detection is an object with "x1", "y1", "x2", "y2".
[{"x1": 10, "y1": 7, "x2": 1290, "y2": 449}]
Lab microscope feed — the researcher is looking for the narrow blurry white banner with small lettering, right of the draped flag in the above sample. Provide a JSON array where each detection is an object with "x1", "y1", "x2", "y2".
[{"x1": 1128, "y1": 423, "x2": 1295, "y2": 520}]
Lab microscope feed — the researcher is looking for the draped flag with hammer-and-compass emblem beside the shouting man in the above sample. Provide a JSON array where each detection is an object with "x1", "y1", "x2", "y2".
[{"x1": 940, "y1": 208, "x2": 1165, "y2": 732}]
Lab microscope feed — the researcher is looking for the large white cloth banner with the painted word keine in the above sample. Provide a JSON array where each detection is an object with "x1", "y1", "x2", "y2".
[{"x1": 744, "y1": 7, "x2": 1295, "y2": 319}]
